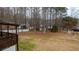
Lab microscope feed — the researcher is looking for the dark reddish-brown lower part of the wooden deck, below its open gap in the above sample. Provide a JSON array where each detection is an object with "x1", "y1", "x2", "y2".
[{"x1": 0, "y1": 32, "x2": 18, "y2": 50}]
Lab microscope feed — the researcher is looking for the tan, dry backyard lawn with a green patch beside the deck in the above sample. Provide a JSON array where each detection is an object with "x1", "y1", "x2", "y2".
[{"x1": 19, "y1": 32, "x2": 79, "y2": 51}]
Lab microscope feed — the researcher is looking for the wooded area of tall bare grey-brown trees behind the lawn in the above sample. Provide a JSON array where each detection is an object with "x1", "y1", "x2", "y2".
[{"x1": 0, "y1": 7, "x2": 77, "y2": 31}]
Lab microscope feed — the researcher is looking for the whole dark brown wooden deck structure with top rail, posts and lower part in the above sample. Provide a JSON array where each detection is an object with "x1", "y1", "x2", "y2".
[{"x1": 0, "y1": 23, "x2": 18, "y2": 50}]
